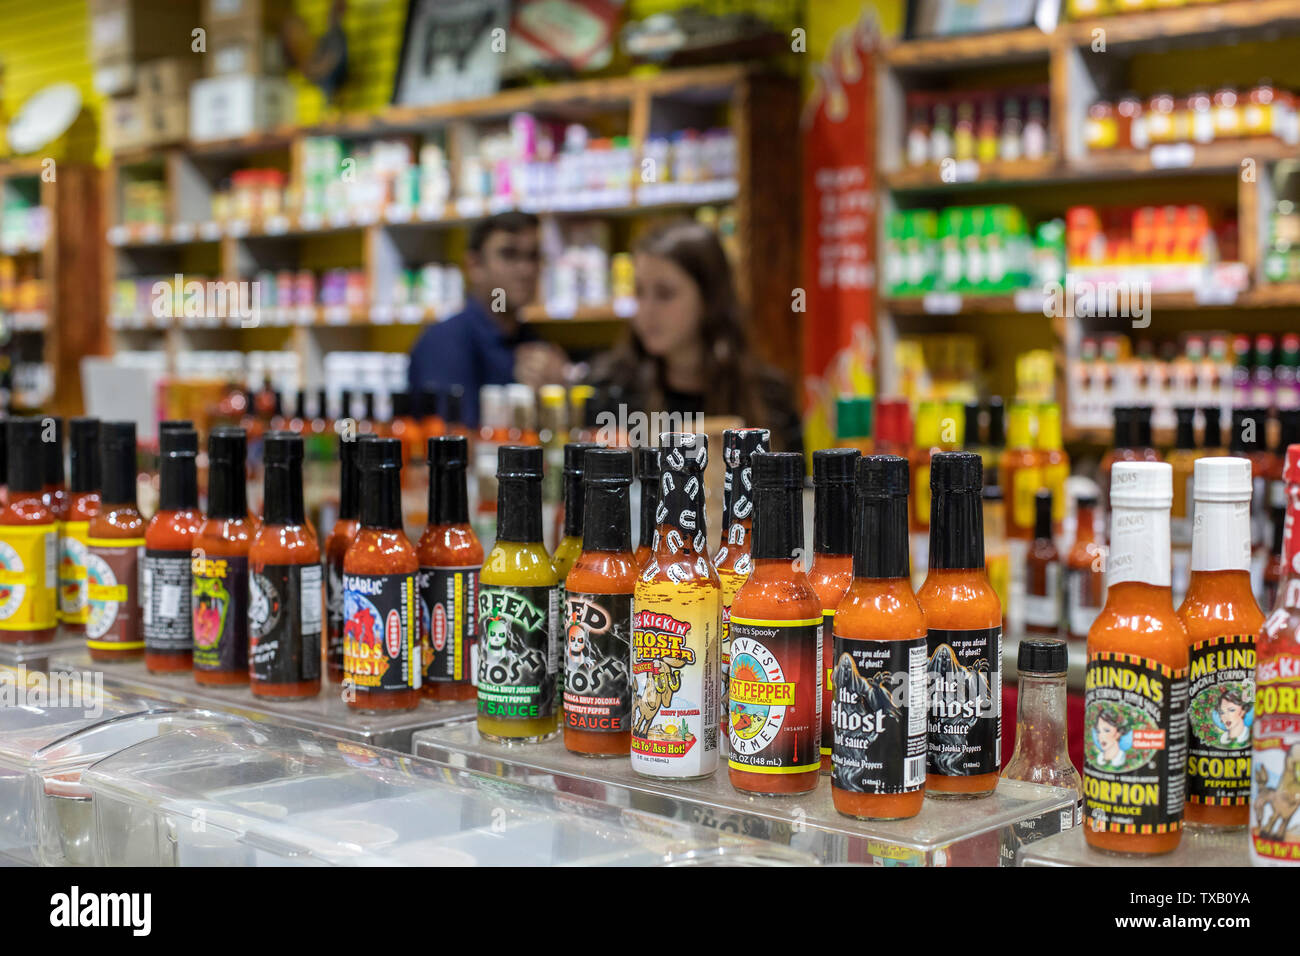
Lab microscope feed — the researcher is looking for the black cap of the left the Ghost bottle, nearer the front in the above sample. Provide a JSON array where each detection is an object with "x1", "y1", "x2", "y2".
[{"x1": 853, "y1": 455, "x2": 911, "y2": 578}]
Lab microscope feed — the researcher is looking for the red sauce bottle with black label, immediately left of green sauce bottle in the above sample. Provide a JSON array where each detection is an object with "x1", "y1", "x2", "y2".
[{"x1": 416, "y1": 436, "x2": 484, "y2": 700}]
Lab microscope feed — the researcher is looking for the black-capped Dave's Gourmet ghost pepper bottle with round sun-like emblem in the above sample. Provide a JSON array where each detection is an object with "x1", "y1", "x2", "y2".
[{"x1": 725, "y1": 451, "x2": 823, "y2": 795}]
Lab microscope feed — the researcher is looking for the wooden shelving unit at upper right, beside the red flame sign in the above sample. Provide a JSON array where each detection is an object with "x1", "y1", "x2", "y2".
[{"x1": 876, "y1": 0, "x2": 1300, "y2": 444}]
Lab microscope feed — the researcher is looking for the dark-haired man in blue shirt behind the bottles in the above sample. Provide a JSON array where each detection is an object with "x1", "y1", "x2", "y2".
[{"x1": 410, "y1": 212, "x2": 567, "y2": 427}]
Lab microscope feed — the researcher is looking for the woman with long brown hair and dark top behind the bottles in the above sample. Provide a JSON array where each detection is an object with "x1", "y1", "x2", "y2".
[{"x1": 589, "y1": 220, "x2": 803, "y2": 451}]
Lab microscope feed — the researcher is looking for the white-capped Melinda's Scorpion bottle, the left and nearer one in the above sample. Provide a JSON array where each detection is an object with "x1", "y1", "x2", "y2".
[{"x1": 1083, "y1": 462, "x2": 1188, "y2": 853}]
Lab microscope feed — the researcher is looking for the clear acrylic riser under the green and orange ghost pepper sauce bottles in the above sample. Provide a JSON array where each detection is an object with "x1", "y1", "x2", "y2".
[{"x1": 415, "y1": 721, "x2": 1076, "y2": 866}]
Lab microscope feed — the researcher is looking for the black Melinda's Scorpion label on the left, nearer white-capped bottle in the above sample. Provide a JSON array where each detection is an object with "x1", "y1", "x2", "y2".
[{"x1": 1083, "y1": 650, "x2": 1187, "y2": 834}]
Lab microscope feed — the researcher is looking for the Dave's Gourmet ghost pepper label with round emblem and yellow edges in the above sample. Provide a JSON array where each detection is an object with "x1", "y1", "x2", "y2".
[{"x1": 727, "y1": 617, "x2": 822, "y2": 774}]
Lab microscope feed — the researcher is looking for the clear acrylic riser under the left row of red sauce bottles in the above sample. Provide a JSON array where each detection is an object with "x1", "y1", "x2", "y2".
[{"x1": 51, "y1": 650, "x2": 476, "y2": 753}]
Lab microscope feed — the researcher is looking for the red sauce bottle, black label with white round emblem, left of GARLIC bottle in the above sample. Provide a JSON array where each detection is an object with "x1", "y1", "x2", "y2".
[{"x1": 248, "y1": 432, "x2": 325, "y2": 700}]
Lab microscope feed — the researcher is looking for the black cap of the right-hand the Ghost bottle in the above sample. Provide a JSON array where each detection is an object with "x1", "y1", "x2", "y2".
[{"x1": 930, "y1": 451, "x2": 984, "y2": 570}]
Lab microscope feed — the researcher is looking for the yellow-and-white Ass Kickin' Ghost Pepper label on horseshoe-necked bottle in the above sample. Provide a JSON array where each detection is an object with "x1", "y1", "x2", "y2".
[{"x1": 632, "y1": 595, "x2": 722, "y2": 778}]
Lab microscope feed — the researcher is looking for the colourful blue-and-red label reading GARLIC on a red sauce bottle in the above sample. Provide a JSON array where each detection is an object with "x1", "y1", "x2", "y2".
[{"x1": 343, "y1": 572, "x2": 424, "y2": 692}]
